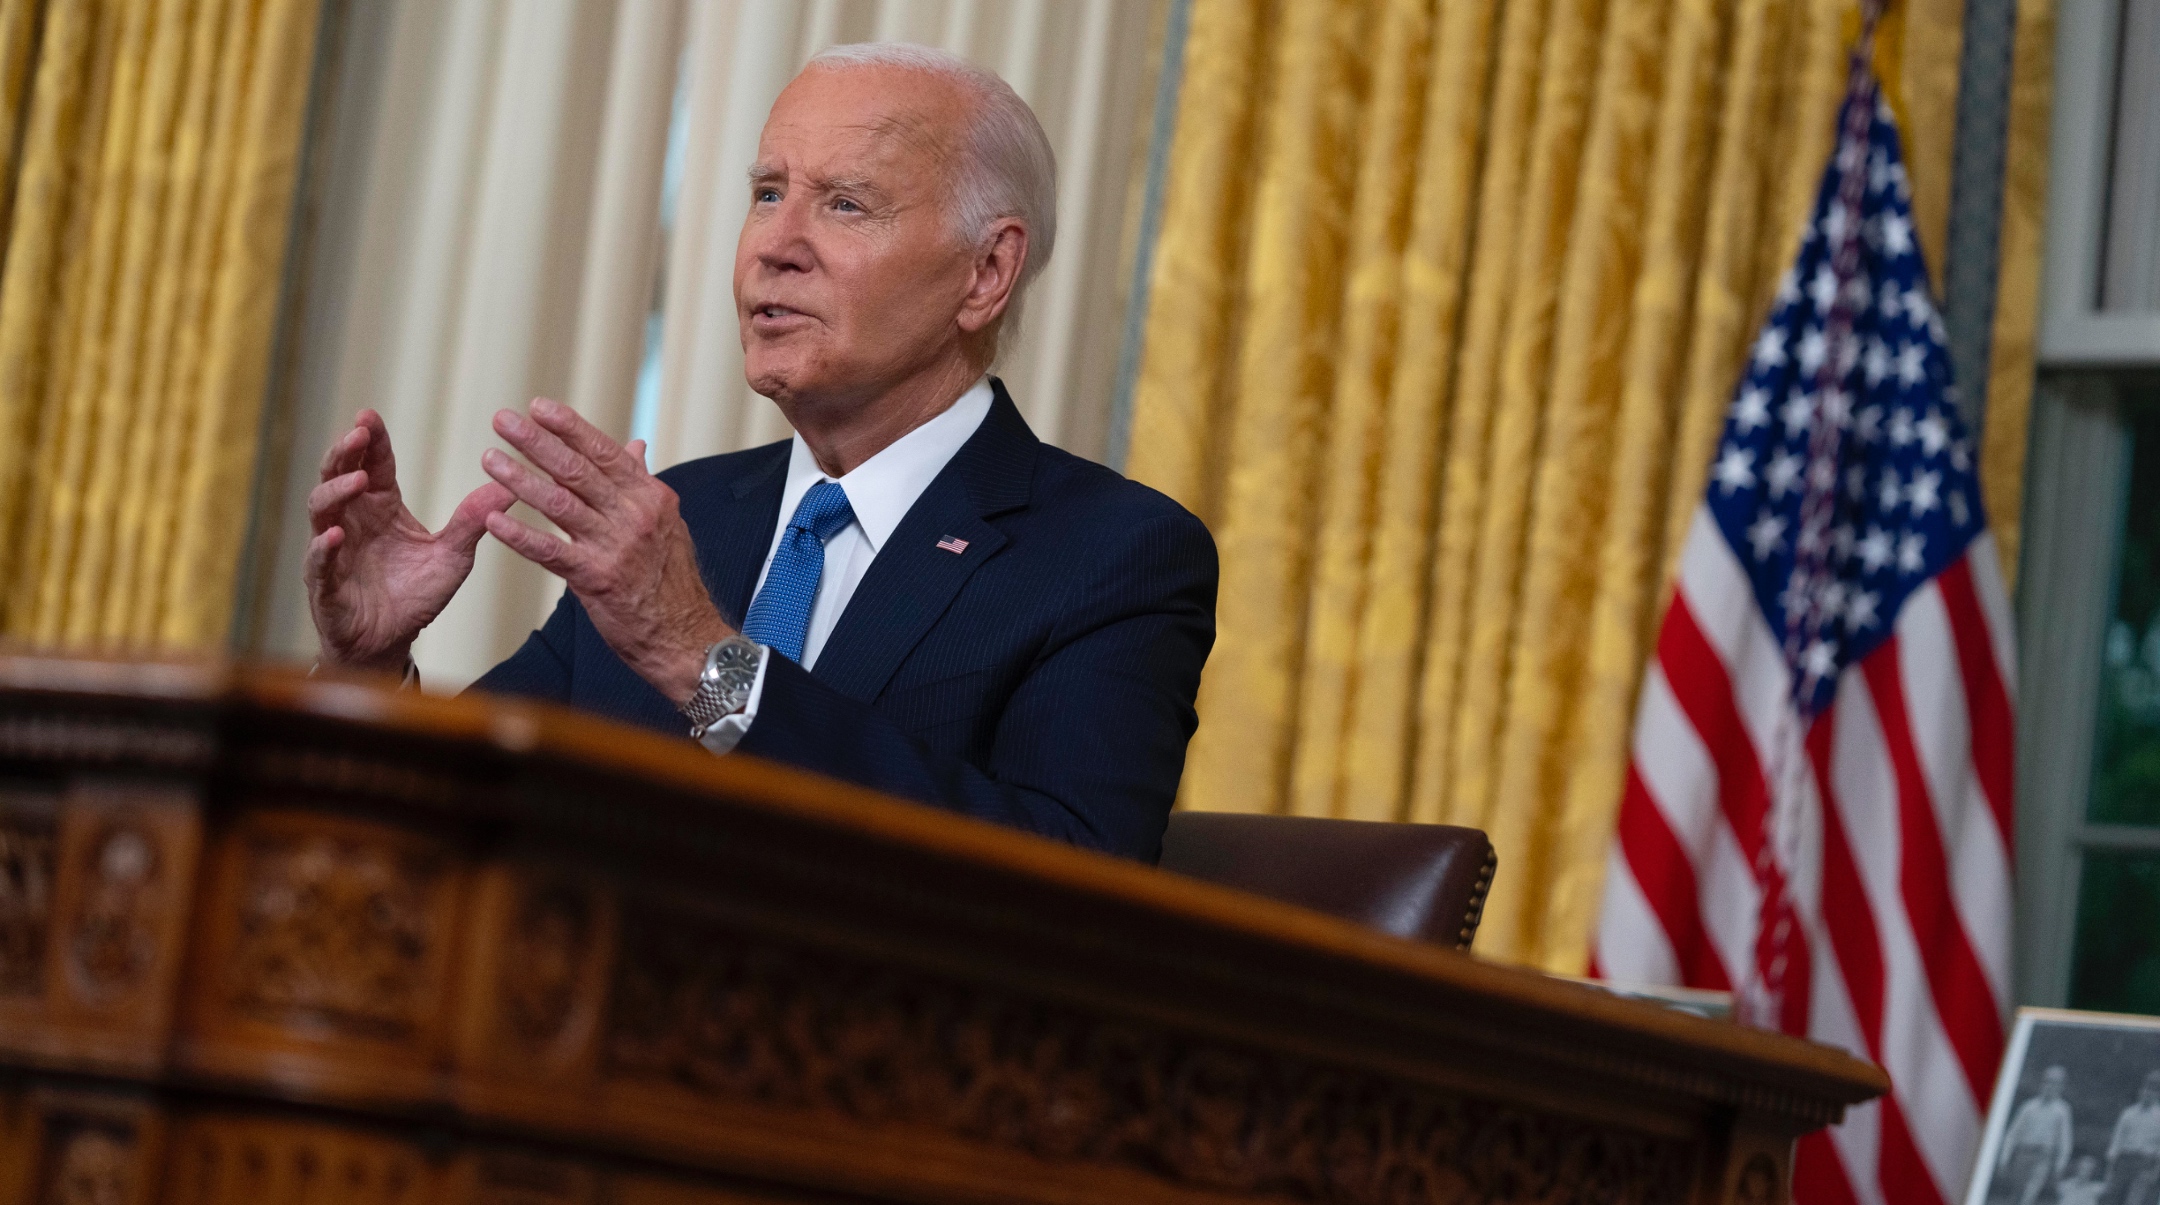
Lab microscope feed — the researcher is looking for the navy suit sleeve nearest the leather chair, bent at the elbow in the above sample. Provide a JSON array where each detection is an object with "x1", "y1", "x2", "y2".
[{"x1": 737, "y1": 512, "x2": 1216, "y2": 862}]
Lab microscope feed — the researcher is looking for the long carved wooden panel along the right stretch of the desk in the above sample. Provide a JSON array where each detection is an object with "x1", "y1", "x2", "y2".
[{"x1": 605, "y1": 911, "x2": 1696, "y2": 1205}]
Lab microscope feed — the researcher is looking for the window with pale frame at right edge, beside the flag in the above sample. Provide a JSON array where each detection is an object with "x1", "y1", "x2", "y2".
[{"x1": 2017, "y1": 0, "x2": 2160, "y2": 1013}]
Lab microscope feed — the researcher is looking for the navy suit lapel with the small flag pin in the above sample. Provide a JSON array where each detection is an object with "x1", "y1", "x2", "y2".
[{"x1": 812, "y1": 378, "x2": 1041, "y2": 702}]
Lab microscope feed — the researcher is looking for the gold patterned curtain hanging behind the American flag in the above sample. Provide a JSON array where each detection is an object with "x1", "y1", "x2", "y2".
[{"x1": 1128, "y1": 0, "x2": 2048, "y2": 970}]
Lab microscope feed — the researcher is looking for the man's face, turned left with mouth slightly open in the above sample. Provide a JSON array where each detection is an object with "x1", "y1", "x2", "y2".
[{"x1": 734, "y1": 67, "x2": 974, "y2": 412}]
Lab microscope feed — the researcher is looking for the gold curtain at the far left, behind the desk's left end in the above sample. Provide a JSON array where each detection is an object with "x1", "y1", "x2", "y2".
[{"x1": 0, "y1": 0, "x2": 322, "y2": 650}]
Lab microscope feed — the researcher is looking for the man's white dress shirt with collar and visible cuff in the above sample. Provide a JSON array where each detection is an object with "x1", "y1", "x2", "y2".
[{"x1": 704, "y1": 376, "x2": 991, "y2": 754}]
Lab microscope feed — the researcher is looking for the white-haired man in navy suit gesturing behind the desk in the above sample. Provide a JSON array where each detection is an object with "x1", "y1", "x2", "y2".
[{"x1": 307, "y1": 45, "x2": 1216, "y2": 859}]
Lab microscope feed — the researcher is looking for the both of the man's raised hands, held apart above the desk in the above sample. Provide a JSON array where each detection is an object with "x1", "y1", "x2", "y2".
[{"x1": 305, "y1": 397, "x2": 734, "y2": 704}]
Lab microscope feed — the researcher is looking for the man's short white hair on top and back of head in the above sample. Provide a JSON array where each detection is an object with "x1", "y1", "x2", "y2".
[{"x1": 804, "y1": 41, "x2": 1058, "y2": 341}]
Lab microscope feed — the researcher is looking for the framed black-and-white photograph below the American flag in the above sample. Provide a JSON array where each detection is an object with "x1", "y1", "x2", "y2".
[{"x1": 1966, "y1": 1008, "x2": 2160, "y2": 1205}]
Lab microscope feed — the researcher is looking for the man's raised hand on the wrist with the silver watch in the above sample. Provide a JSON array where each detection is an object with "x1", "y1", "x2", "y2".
[{"x1": 480, "y1": 397, "x2": 734, "y2": 706}]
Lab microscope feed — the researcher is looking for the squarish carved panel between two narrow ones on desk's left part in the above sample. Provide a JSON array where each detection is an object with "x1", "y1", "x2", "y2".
[{"x1": 229, "y1": 834, "x2": 445, "y2": 1039}]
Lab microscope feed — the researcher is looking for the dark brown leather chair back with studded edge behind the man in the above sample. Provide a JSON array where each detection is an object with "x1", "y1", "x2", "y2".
[{"x1": 1162, "y1": 812, "x2": 1499, "y2": 950}]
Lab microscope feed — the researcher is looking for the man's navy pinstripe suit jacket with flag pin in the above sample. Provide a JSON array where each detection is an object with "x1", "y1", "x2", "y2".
[{"x1": 475, "y1": 380, "x2": 1216, "y2": 862}]
